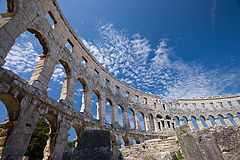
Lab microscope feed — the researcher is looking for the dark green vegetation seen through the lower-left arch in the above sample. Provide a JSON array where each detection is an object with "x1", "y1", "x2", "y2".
[{"x1": 25, "y1": 117, "x2": 50, "y2": 160}]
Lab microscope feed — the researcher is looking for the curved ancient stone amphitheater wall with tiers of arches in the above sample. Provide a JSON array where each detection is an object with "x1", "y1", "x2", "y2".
[{"x1": 0, "y1": 0, "x2": 240, "y2": 160}]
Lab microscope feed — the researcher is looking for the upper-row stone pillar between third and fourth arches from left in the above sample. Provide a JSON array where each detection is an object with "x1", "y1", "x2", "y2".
[{"x1": 81, "y1": 90, "x2": 93, "y2": 115}]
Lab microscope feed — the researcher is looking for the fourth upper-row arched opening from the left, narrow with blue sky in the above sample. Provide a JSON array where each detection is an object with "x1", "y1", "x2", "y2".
[{"x1": 92, "y1": 91, "x2": 100, "y2": 119}]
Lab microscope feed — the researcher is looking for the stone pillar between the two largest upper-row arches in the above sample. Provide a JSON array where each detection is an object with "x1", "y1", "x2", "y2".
[{"x1": 29, "y1": 53, "x2": 57, "y2": 94}]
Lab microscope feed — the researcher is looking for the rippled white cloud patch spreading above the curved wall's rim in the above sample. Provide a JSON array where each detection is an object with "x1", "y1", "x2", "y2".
[{"x1": 83, "y1": 23, "x2": 240, "y2": 99}]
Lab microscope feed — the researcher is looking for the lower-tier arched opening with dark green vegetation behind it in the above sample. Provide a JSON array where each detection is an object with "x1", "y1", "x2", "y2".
[{"x1": 24, "y1": 114, "x2": 58, "y2": 159}]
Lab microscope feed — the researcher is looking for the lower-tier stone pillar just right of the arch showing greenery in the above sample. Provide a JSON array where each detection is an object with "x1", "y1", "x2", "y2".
[{"x1": 44, "y1": 120, "x2": 71, "y2": 160}]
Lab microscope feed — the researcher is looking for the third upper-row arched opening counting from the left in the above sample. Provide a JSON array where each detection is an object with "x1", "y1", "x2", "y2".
[{"x1": 73, "y1": 78, "x2": 86, "y2": 111}]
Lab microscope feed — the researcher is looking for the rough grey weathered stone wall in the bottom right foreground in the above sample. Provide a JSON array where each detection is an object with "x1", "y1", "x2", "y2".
[{"x1": 177, "y1": 125, "x2": 240, "y2": 160}]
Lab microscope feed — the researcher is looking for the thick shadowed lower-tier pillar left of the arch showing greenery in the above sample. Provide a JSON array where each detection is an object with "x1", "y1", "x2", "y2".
[{"x1": 2, "y1": 97, "x2": 39, "y2": 159}]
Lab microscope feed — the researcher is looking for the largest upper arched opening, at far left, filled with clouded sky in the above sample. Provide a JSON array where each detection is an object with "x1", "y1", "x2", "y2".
[{"x1": 3, "y1": 29, "x2": 48, "y2": 81}]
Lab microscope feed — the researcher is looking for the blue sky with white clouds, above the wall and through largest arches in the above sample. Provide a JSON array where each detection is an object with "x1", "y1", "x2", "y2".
[{"x1": 0, "y1": 0, "x2": 240, "y2": 141}]
